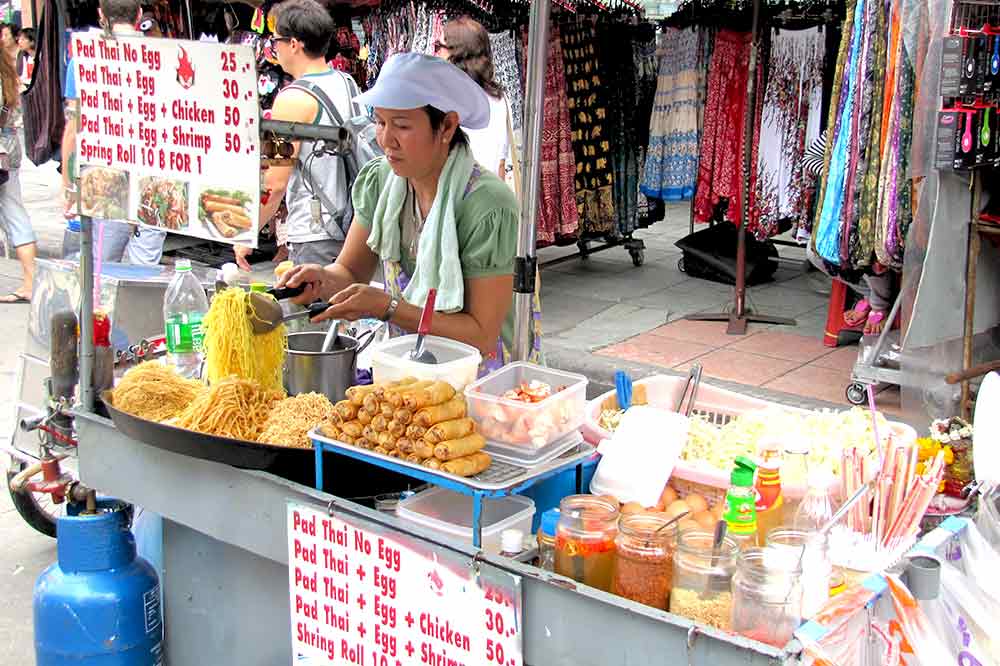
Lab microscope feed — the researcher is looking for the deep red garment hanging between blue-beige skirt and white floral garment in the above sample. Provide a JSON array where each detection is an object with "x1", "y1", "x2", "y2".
[{"x1": 694, "y1": 30, "x2": 762, "y2": 224}]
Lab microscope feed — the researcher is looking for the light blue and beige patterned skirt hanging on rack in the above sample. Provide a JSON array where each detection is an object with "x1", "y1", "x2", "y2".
[{"x1": 640, "y1": 28, "x2": 705, "y2": 201}]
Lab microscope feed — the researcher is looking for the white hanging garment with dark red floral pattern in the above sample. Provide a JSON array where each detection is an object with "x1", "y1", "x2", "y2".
[{"x1": 747, "y1": 28, "x2": 826, "y2": 240}]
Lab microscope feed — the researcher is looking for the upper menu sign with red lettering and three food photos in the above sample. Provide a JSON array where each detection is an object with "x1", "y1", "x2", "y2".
[{"x1": 73, "y1": 32, "x2": 260, "y2": 246}]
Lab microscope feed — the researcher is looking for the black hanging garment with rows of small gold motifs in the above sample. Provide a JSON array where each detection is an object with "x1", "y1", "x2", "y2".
[{"x1": 562, "y1": 19, "x2": 615, "y2": 235}]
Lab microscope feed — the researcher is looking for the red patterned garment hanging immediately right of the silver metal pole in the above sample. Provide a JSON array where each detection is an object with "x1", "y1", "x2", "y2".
[{"x1": 522, "y1": 23, "x2": 580, "y2": 247}]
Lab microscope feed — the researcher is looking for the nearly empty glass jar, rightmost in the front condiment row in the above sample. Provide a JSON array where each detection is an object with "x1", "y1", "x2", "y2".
[{"x1": 732, "y1": 548, "x2": 802, "y2": 647}]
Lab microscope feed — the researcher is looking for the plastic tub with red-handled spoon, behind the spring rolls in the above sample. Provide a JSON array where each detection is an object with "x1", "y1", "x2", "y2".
[{"x1": 371, "y1": 335, "x2": 483, "y2": 391}]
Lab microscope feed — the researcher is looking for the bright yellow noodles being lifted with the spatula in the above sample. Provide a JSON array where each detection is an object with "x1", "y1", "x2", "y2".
[{"x1": 202, "y1": 287, "x2": 287, "y2": 391}]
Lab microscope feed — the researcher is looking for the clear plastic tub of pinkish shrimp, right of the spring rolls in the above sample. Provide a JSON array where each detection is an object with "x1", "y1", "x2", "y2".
[{"x1": 465, "y1": 363, "x2": 587, "y2": 449}]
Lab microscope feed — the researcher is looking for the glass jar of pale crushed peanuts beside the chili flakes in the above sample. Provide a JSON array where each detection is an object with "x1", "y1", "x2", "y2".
[{"x1": 670, "y1": 530, "x2": 740, "y2": 631}]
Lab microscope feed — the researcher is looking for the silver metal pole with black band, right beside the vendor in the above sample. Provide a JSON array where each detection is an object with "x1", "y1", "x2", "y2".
[{"x1": 513, "y1": 0, "x2": 550, "y2": 361}]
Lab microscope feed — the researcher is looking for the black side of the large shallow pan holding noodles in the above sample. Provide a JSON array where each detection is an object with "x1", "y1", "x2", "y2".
[{"x1": 101, "y1": 391, "x2": 312, "y2": 470}]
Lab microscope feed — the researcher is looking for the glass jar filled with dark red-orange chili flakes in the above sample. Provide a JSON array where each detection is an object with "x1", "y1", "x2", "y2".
[{"x1": 611, "y1": 514, "x2": 677, "y2": 610}]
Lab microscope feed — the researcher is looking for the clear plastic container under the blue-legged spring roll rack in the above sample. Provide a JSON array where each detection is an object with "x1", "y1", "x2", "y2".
[{"x1": 396, "y1": 488, "x2": 535, "y2": 554}]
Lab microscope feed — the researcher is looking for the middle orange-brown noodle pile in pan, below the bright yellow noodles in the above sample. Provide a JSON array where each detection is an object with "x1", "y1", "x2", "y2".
[{"x1": 174, "y1": 377, "x2": 284, "y2": 442}]
